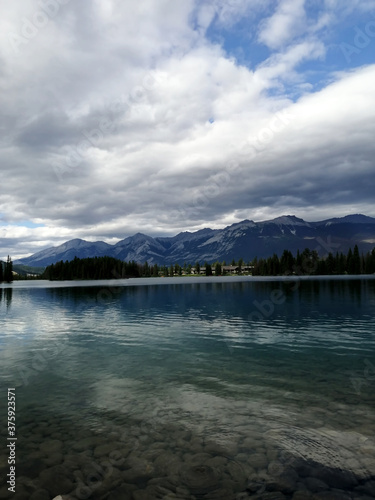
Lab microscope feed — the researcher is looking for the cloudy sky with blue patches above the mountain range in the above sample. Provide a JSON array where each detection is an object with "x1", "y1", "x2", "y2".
[{"x1": 0, "y1": 0, "x2": 375, "y2": 260}]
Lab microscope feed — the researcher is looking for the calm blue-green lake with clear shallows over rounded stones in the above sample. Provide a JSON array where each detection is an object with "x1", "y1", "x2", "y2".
[{"x1": 0, "y1": 278, "x2": 375, "y2": 500}]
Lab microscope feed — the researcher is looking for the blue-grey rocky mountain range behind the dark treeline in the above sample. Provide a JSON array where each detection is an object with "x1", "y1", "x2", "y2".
[{"x1": 15, "y1": 214, "x2": 375, "y2": 266}]
